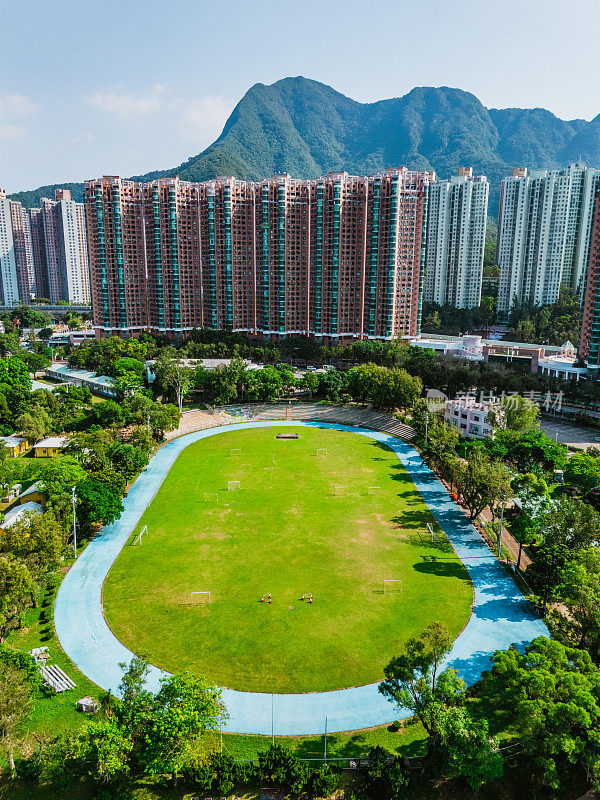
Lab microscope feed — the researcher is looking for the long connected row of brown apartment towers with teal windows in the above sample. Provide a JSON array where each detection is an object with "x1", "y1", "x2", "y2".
[{"x1": 85, "y1": 168, "x2": 434, "y2": 343}]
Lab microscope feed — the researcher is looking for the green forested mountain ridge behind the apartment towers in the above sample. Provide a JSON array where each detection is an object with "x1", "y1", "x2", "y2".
[{"x1": 12, "y1": 77, "x2": 600, "y2": 213}]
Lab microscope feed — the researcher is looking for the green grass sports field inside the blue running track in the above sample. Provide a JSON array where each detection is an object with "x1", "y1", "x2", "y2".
[{"x1": 103, "y1": 426, "x2": 472, "y2": 692}]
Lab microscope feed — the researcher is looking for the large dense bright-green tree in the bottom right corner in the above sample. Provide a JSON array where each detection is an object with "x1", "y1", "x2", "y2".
[{"x1": 480, "y1": 637, "x2": 600, "y2": 790}]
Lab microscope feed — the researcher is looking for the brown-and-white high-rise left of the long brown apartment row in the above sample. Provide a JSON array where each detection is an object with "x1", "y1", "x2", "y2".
[{"x1": 40, "y1": 189, "x2": 90, "y2": 303}]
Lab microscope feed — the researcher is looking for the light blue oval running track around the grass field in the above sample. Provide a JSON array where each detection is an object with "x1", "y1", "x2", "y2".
[{"x1": 54, "y1": 421, "x2": 548, "y2": 735}]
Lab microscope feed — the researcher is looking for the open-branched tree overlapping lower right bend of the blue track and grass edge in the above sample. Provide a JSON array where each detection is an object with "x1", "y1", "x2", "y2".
[{"x1": 379, "y1": 622, "x2": 465, "y2": 737}]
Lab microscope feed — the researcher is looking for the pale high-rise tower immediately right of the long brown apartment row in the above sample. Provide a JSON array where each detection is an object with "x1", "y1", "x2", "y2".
[{"x1": 424, "y1": 167, "x2": 489, "y2": 308}]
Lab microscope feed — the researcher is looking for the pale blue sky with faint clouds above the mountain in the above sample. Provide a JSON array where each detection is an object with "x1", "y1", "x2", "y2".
[{"x1": 0, "y1": 0, "x2": 600, "y2": 191}]
